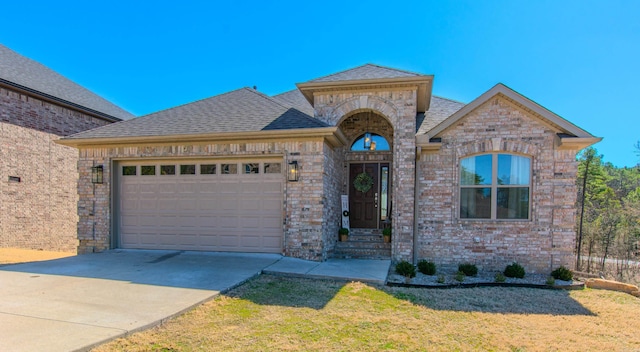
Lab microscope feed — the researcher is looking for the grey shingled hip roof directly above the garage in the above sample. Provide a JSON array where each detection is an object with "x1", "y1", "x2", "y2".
[{"x1": 67, "y1": 88, "x2": 328, "y2": 139}]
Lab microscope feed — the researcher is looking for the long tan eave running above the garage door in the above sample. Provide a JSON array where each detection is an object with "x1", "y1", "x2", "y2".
[{"x1": 55, "y1": 127, "x2": 347, "y2": 148}]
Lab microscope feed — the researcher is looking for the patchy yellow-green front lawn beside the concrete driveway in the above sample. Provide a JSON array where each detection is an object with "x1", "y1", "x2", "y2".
[{"x1": 95, "y1": 275, "x2": 640, "y2": 351}]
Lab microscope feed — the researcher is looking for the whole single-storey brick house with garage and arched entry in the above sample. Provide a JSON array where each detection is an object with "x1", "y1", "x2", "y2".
[{"x1": 59, "y1": 65, "x2": 600, "y2": 273}]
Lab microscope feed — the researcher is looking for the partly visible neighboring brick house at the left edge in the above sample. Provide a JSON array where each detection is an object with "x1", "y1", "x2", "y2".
[{"x1": 0, "y1": 45, "x2": 133, "y2": 251}]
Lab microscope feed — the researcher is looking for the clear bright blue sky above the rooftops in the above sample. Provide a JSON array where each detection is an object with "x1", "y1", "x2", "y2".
[{"x1": 0, "y1": 0, "x2": 640, "y2": 166}]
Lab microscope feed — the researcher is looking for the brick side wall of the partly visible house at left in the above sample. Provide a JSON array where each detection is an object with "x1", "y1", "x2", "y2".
[{"x1": 0, "y1": 88, "x2": 109, "y2": 251}]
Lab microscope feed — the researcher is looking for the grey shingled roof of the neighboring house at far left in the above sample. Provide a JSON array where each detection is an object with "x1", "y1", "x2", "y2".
[{"x1": 0, "y1": 44, "x2": 135, "y2": 121}]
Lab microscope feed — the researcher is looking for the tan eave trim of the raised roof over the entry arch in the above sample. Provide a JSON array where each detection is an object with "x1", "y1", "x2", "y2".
[{"x1": 296, "y1": 75, "x2": 433, "y2": 112}]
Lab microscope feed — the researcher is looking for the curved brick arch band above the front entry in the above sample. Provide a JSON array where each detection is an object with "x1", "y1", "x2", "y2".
[{"x1": 327, "y1": 95, "x2": 398, "y2": 128}]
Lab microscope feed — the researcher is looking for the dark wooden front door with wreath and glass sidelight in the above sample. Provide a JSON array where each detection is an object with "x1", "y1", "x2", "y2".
[{"x1": 349, "y1": 163, "x2": 389, "y2": 229}]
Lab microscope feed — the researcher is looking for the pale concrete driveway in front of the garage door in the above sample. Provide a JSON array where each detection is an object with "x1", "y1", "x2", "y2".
[{"x1": 0, "y1": 250, "x2": 282, "y2": 351}]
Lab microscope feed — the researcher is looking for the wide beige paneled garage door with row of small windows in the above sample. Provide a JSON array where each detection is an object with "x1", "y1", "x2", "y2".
[{"x1": 117, "y1": 160, "x2": 284, "y2": 253}]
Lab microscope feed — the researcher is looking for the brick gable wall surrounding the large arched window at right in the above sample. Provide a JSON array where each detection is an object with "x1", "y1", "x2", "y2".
[{"x1": 417, "y1": 97, "x2": 576, "y2": 273}]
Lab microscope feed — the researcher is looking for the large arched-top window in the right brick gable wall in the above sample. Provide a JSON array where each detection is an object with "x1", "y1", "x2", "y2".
[{"x1": 460, "y1": 154, "x2": 531, "y2": 219}]
